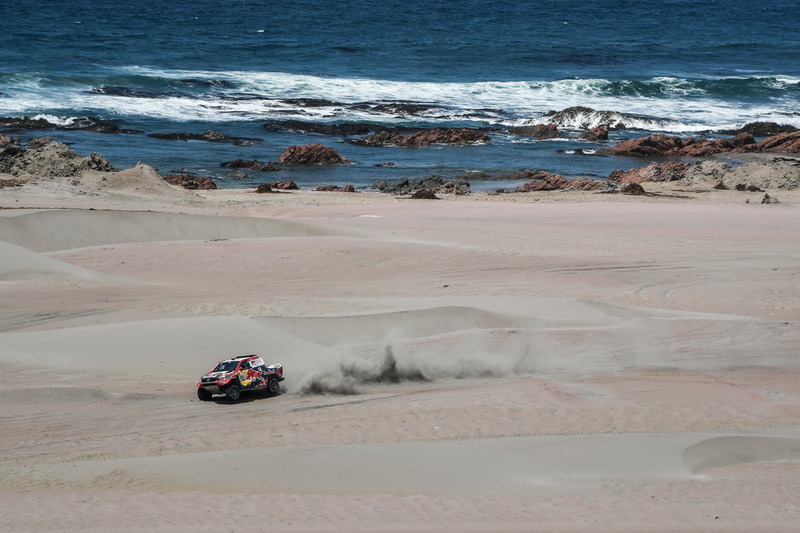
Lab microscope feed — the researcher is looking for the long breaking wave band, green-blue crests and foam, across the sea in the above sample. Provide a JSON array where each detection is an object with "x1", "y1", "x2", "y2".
[{"x1": 0, "y1": 67, "x2": 800, "y2": 132}]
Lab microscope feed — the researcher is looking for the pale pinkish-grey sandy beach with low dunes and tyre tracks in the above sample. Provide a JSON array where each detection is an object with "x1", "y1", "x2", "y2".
[{"x1": 0, "y1": 165, "x2": 800, "y2": 532}]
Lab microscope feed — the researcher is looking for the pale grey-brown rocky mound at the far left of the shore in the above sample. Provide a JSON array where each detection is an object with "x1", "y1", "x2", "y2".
[{"x1": 0, "y1": 142, "x2": 117, "y2": 178}]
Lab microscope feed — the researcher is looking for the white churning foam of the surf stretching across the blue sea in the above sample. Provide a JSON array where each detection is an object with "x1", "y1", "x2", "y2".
[{"x1": 0, "y1": 67, "x2": 800, "y2": 132}]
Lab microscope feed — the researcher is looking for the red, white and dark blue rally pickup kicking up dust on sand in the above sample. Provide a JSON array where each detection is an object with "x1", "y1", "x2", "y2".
[{"x1": 197, "y1": 354, "x2": 283, "y2": 402}]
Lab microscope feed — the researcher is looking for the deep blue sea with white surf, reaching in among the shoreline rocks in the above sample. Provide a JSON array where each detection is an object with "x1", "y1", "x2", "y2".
[{"x1": 0, "y1": 0, "x2": 800, "y2": 189}]
